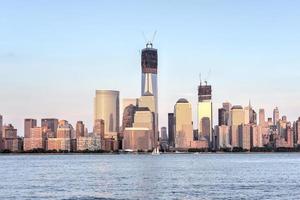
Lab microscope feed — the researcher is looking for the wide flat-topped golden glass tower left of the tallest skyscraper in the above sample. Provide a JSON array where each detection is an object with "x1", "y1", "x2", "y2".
[{"x1": 94, "y1": 90, "x2": 120, "y2": 139}]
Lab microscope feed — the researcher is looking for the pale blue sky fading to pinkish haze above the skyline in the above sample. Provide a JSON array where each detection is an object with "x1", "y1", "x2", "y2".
[{"x1": 0, "y1": 0, "x2": 300, "y2": 135}]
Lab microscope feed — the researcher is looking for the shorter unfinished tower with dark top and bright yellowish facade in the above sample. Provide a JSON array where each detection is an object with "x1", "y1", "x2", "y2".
[{"x1": 198, "y1": 83, "x2": 213, "y2": 146}]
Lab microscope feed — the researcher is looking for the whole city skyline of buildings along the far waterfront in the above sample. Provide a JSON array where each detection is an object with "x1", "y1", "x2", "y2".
[{"x1": 0, "y1": 42, "x2": 300, "y2": 152}]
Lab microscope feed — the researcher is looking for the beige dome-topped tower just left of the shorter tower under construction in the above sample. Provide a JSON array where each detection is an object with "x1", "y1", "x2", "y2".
[{"x1": 174, "y1": 98, "x2": 194, "y2": 148}]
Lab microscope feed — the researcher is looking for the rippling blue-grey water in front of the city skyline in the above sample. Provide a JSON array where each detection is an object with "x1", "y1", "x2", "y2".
[{"x1": 0, "y1": 153, "x2": 300, "y2": 200}]
